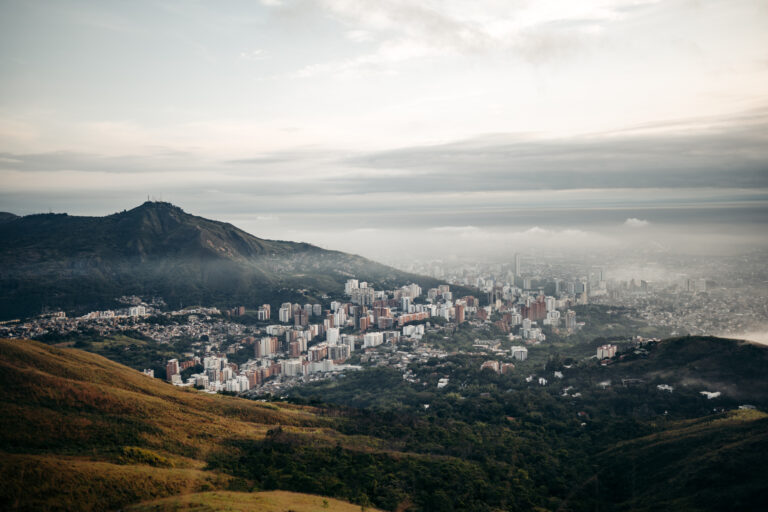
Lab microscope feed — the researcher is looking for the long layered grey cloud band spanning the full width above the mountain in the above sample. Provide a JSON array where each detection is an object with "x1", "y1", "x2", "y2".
[{"x1": 0, "y1": 110, "x2": 768, "y2": 206}]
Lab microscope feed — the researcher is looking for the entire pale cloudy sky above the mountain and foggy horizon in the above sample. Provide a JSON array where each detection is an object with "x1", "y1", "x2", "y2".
[{"x1": 0, "y1": 0, "x2": 768, "y2": 260}]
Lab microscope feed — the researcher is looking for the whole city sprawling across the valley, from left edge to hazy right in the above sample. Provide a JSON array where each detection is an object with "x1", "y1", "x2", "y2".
[{"x1": 0, "y1": 250, "x2": 766, "y2": 397}]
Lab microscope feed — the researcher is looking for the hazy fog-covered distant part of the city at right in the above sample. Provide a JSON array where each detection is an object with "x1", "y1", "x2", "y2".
[{"x1": 402, "y1": 251, "x2": 768, "y2": 336}]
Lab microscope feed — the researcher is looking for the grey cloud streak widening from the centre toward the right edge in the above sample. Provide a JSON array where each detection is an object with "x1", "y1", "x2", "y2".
[{"x1": 347, "y1": 109, "x2": 768, "y2": 191}]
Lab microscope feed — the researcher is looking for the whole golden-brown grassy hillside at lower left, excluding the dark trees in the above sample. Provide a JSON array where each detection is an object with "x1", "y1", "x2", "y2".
[{"x1": 0, "y1": 340, "x2": 396, "y2": 511}]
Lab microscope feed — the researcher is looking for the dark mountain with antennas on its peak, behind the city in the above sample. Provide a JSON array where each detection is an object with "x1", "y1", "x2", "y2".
[{"x1": 0, "y1": 202, "x2": 452, "y2": 319}]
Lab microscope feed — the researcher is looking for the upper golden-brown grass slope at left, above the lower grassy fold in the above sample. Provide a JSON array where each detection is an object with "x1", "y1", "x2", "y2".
[{"x1": 0, "y1": 340, "x2": 327, "y2": 459}]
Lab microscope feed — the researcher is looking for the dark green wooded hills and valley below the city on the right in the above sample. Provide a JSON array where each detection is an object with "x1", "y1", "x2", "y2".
[{"x1": 284, "y1": 337, "x2": 768, "y2": 510}]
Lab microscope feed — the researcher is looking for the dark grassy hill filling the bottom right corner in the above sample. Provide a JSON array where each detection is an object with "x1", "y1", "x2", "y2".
[{"x1": 586, "y1": 410, "x2": 768, "y2": 512}]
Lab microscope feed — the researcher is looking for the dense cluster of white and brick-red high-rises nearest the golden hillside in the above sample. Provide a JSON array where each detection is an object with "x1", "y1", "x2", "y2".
[{"x1": 166, "y1": 279, "x2": 477, "y2": 393}]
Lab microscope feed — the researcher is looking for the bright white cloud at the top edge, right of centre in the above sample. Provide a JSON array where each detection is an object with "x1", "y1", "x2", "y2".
[{"x1": 294, "y1": 0, "x2": 657, "y2": 78}]
